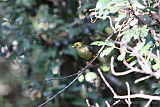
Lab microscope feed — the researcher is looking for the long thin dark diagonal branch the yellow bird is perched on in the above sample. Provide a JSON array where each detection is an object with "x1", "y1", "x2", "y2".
[{"x1": 38, "y1": 45, "x2": 105, "y2": 107}]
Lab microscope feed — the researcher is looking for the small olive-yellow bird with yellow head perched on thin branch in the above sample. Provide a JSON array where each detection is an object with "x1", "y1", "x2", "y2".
[{"x1": 72, "y1": 42, "x2": 100, "y2": 65}]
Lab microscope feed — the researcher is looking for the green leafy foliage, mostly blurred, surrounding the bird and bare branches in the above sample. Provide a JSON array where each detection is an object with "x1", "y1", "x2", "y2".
[{"x1": 0, "y1": 0, "x2": 160, "y2": 107}]
